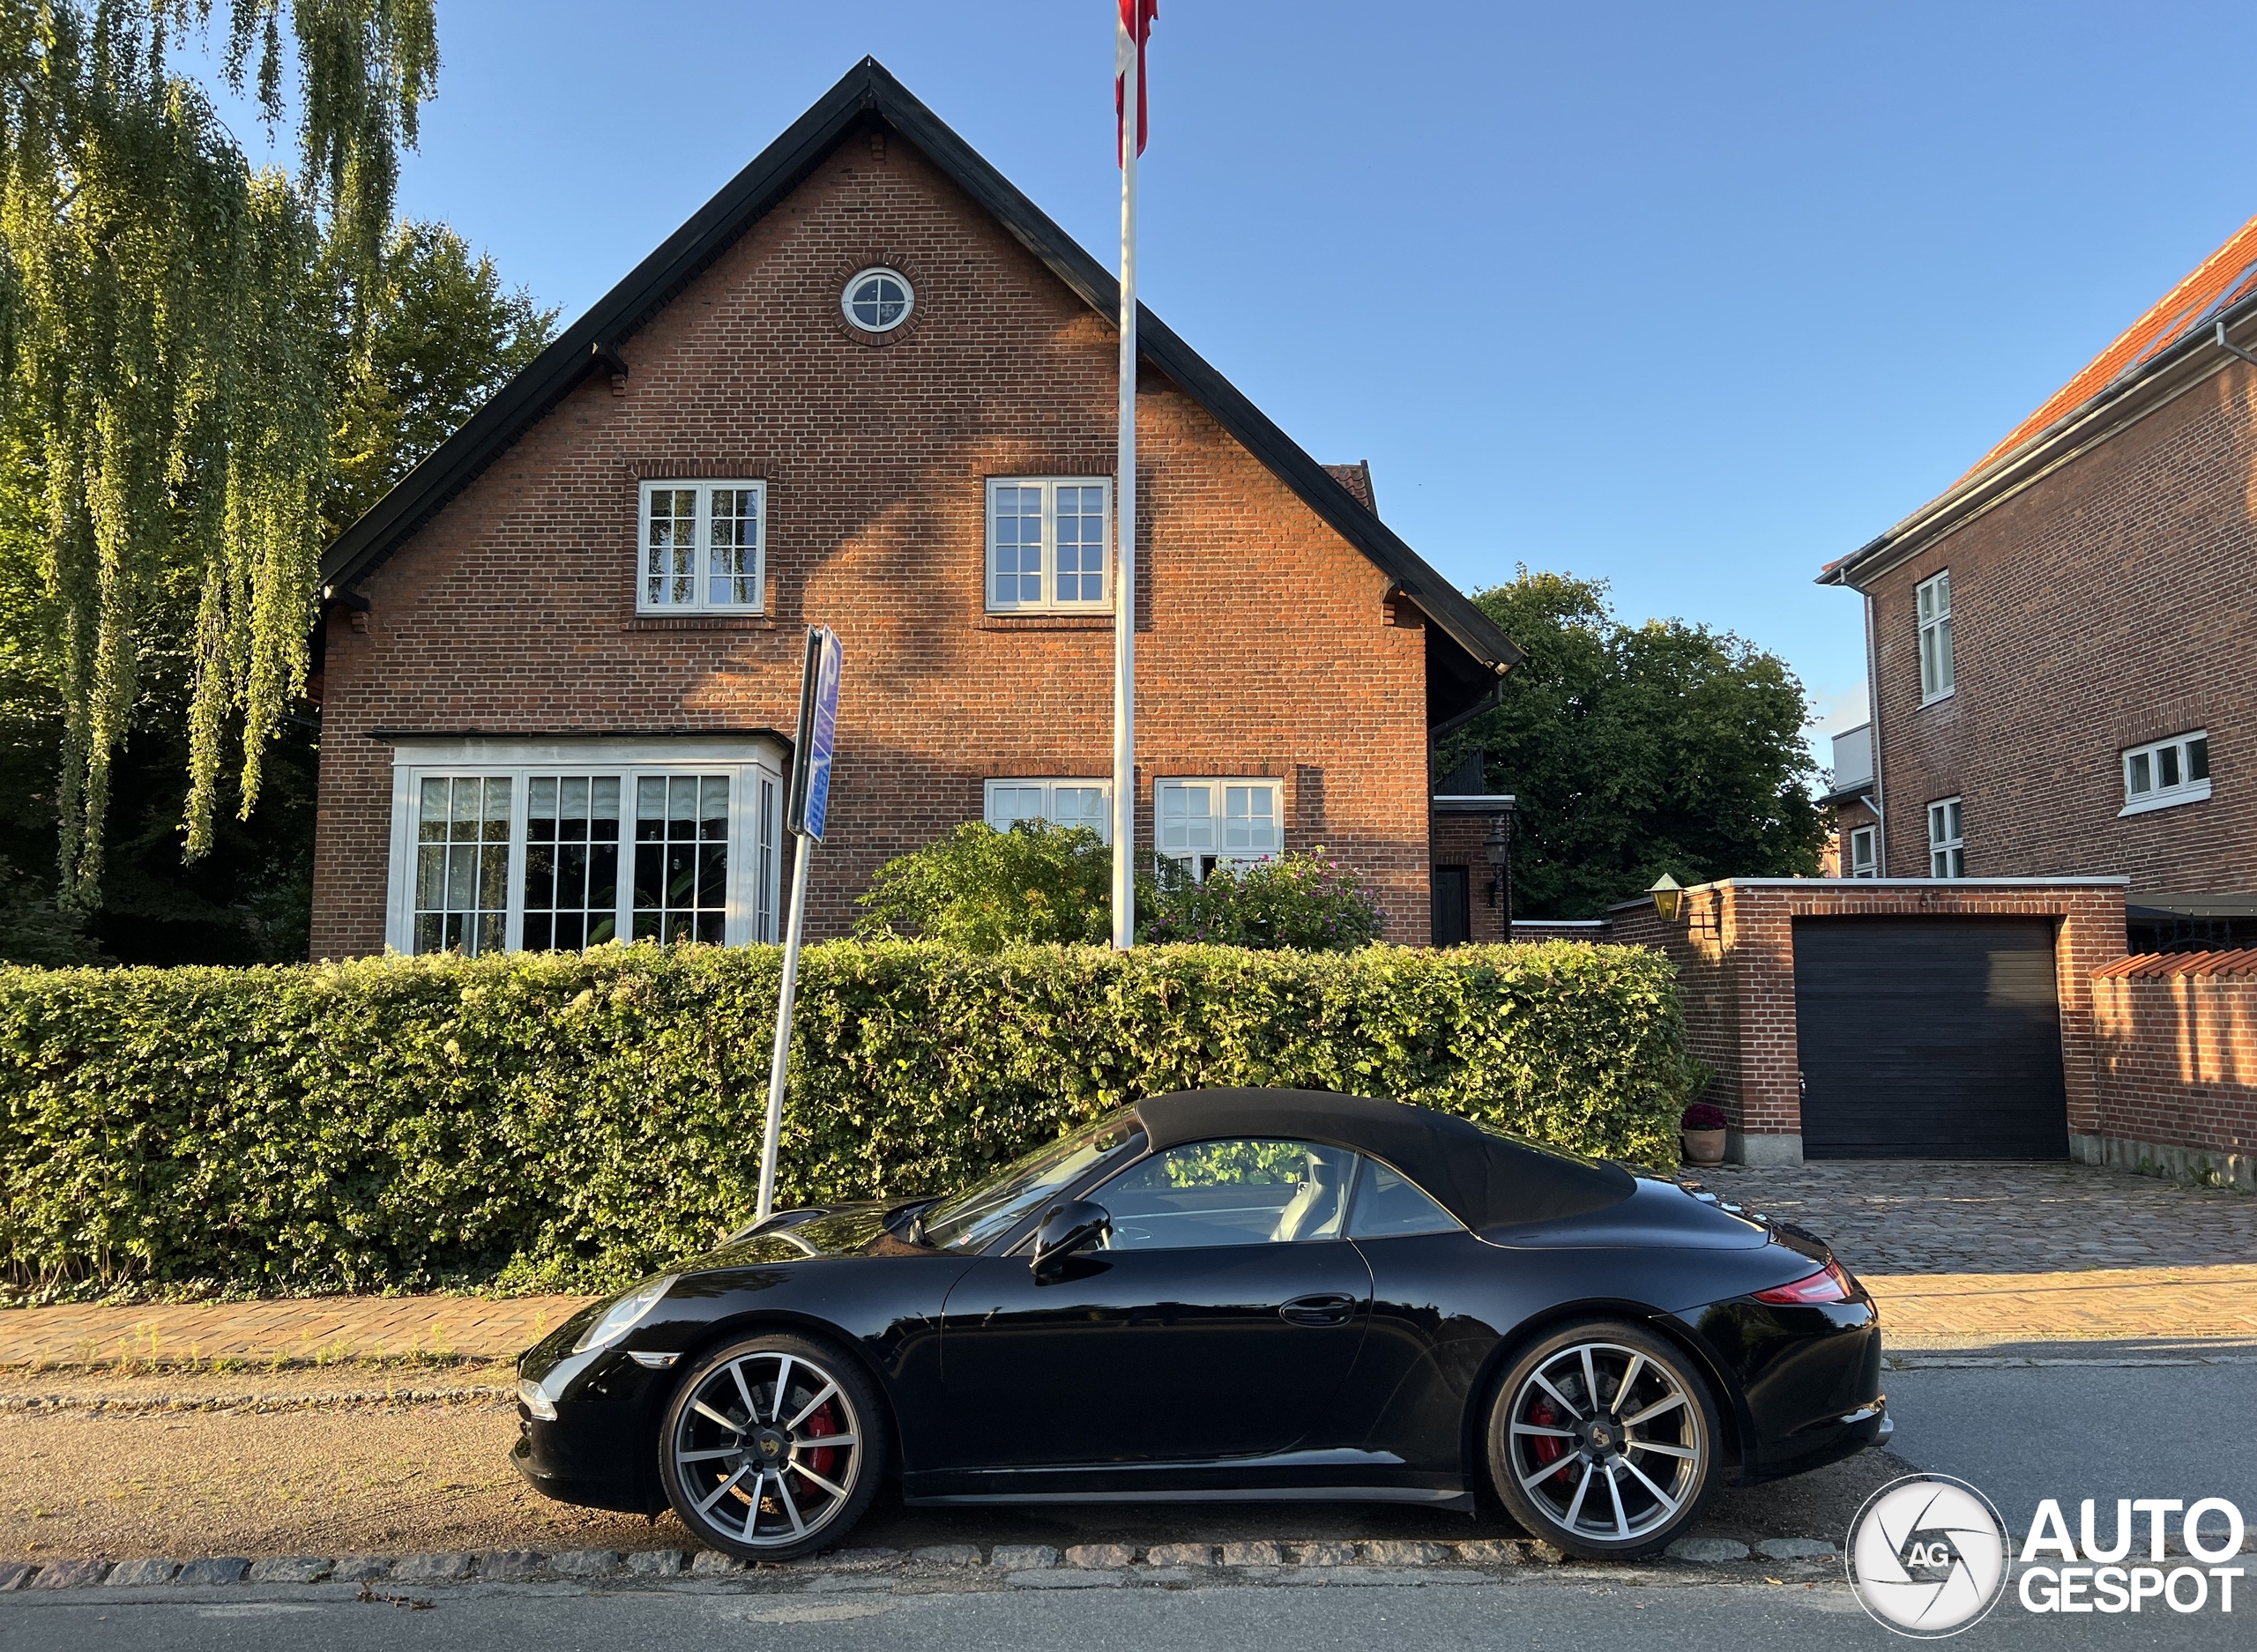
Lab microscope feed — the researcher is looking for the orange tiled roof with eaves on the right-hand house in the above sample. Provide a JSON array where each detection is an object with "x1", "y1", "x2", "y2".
[{"x1": 1817, "y1": 219, "x2": 2257, "y2": 587}]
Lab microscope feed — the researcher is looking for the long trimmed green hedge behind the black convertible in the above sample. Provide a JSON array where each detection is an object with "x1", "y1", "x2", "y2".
[{"x1": 0, "y1": 941, "x2": 1693, "y2": 1300}]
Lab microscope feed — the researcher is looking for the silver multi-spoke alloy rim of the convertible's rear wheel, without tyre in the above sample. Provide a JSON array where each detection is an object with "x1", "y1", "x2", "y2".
[{"x1": 1503, "y1": 1341, "x2": 1709, "y2": 1544}]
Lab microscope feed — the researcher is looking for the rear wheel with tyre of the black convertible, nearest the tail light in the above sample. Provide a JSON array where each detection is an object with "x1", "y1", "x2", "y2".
[{"x1": 1490, "y1": 1321, "x2": 1717, "y2": 1559}]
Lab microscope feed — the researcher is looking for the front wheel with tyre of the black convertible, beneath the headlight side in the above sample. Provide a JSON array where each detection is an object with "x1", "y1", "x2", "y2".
[{"x1": 659, "y1": 1331, "x2": 885, "y2": 1559}]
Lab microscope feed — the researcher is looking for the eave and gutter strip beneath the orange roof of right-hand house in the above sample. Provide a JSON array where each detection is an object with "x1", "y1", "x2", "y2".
[{"x1": 1817, "y1": 294, "x2": 2257, "y2": 589}]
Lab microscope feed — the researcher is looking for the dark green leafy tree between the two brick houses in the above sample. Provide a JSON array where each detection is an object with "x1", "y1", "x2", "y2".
[{"x1": 1435, "y1": 569, "x2": 1826, "y2": 919}]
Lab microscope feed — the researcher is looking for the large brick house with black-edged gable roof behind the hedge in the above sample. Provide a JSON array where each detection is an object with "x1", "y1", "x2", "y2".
[{"x1": 314, "y1": 59, "x2": 1519, "y2": 956}]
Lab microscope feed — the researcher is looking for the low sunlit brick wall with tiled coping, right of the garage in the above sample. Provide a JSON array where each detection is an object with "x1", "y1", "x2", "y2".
[{"x1": 2092, "y1": 952, "x2": 2257, "y2": 1156}]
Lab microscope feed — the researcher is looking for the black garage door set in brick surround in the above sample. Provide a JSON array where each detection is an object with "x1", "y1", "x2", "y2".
[{"x1": 1794, "y1": 919, "x2": 2070, "y2": 1157}]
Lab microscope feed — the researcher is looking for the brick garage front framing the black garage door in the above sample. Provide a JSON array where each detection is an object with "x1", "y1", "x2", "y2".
[{"x1": 1612, "y1": 878, "x2": 2124, "y2": 1135}]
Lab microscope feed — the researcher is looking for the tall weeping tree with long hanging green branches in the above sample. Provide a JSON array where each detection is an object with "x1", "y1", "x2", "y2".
[{"x1": 0, "y1": 0, "x2": 438, "y2": 905}]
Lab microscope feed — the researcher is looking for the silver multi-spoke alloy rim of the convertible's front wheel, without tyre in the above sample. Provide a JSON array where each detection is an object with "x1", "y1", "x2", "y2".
[{"x1": 673, "y1": 1350, "x2": 867, "y2": 1548}]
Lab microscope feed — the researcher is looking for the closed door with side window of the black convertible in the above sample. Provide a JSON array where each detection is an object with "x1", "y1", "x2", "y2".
[{"x1": 942, "y1": 1140, "x2": 1372, "y2": 1470}]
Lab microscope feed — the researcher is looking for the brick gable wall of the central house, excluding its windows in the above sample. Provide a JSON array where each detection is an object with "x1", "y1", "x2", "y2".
[{"x1": 314, "y1": 138, "x2": 1428, "y2": 956}]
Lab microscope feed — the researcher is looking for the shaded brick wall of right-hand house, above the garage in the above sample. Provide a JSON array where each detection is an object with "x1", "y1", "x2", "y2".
[{"x1": 1866, "y1": 363, "x2": 2257, "y2": 894}]
